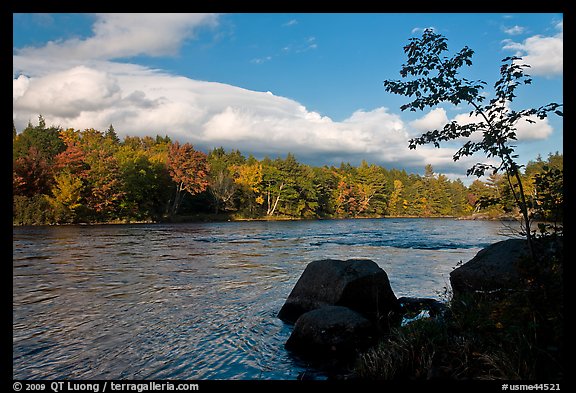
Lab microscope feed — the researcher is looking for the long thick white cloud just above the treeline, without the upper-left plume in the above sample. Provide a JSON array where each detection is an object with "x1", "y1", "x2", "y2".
[{"x1": 13, "y1": 57, "x2": 464, "y2": 172}]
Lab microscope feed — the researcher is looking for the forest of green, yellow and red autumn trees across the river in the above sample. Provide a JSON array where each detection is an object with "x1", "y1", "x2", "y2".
[{"x1": 12, "y1": 116, "x2": 563, "y2": 225}]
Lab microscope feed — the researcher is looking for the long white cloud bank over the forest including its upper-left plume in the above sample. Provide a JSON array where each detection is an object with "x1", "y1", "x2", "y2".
[{"x1": 13, "y1": 14, "x2": 551, "y2": 177}]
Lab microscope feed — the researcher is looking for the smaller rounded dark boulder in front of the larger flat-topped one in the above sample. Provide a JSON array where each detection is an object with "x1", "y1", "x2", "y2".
[{"x1": 285, "y1": 306, "x2": 376, "y2": 359}]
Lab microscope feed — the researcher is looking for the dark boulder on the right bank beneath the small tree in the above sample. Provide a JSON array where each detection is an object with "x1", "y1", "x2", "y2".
[{"x1": 450, "y1": 239, "x2": 530, "y2": 296}]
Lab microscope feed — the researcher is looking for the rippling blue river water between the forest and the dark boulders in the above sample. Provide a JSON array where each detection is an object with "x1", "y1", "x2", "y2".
[{"x1": 12, "y1": 218, "x2": 510, "y2": 380}]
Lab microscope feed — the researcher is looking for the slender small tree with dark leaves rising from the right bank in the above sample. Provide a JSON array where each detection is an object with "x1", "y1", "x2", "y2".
[{"x1": 384, "y1": 29, "x2": 563, "y2": 258}]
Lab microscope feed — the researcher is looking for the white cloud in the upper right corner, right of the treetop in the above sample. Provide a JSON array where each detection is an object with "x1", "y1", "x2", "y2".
[{"x1": 503, "y1": 22, "x2": 564, "y2": 76}]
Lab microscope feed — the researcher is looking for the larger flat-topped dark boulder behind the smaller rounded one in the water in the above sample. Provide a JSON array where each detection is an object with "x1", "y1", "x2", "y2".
[{"x1": 278, "y1": 259, "x2": 399, "y2": 325}]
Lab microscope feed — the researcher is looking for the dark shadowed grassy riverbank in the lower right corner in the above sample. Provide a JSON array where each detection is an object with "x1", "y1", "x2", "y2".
[{"x1": 348, "y1": 234, "x2": 565, "y2": 381}]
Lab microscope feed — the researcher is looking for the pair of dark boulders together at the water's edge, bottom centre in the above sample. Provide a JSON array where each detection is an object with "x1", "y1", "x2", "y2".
[{"x1": 278, "y1": 259, "x2": 400, "y2": 357}]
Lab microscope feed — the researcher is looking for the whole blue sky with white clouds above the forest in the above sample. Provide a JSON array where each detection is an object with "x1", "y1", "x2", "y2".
[{"x1": 12, "y1": 13, "x2": 563, "y2": 184}]
